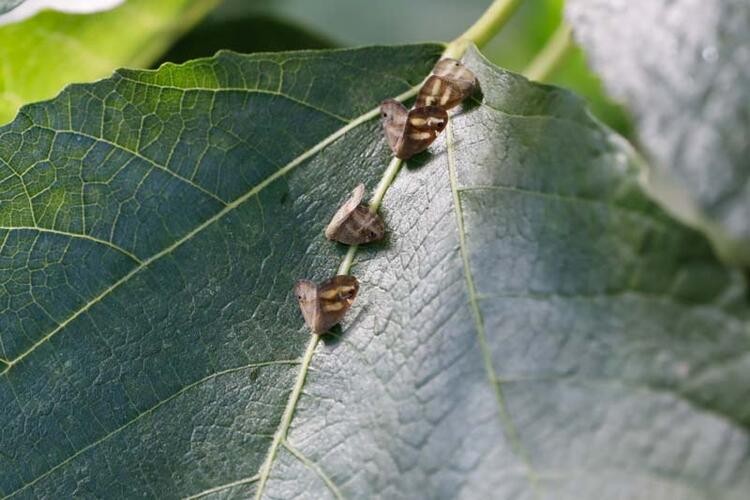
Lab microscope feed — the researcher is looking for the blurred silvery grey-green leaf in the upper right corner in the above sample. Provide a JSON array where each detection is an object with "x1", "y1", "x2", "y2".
[{"x1": 568, "y1": 0, "x2": 750, "y2": 265}]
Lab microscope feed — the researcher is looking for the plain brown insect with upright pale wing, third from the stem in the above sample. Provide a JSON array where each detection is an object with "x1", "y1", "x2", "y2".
[{"x1": 326, "y1": 184, "x2": 385, "y2": 245}]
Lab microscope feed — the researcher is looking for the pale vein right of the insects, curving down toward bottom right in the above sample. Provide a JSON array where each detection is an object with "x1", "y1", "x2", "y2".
[{"x1": 445, "y1": 120, "x2": 537, "y2": 491}]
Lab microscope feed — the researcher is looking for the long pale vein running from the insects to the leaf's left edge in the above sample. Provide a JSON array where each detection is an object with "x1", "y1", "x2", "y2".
[{"x1": 0, "y1": 87, "x2": 418, "y2": 375}]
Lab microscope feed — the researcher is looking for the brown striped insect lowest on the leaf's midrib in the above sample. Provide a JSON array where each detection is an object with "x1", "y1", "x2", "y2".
[{"x1": 294, "y1": 274, "x2": 359, "y2": 334}]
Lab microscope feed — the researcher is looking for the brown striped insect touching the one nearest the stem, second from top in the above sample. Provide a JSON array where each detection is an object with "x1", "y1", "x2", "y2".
[{"x1": 380, "y1": 99, "x2": 448, "y2": 160}]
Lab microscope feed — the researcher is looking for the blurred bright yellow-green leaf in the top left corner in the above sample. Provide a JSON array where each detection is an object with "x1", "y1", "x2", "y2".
[{"x1": 0, "y1": 0, "x2": 218, "y2": 124}]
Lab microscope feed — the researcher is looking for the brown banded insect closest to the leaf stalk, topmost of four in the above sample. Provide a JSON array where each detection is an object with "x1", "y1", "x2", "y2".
[{"x1": 414, "y1": 59, "x2": 478, "y2": 109}]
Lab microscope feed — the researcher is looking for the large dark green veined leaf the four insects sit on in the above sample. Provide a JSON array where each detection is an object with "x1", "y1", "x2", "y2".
[{"x1": 0, "y1": 45, "x2": 750, "y2": 499}]
